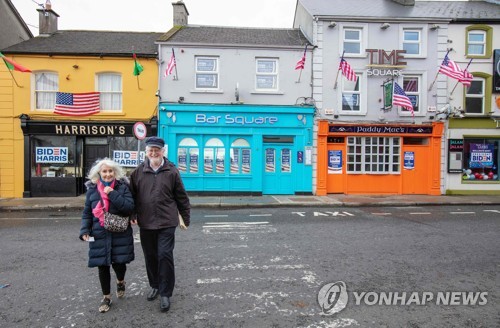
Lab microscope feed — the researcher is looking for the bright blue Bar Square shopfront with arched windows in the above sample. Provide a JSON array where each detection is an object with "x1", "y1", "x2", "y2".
[{"x1": 158, "y1": 103, "x2": 315, "y2": 194}]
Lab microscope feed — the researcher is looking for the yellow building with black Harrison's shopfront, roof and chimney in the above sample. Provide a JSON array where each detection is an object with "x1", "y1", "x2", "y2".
[{"x1": 0, "y1": 9, "x2": 161, "y2": 198}]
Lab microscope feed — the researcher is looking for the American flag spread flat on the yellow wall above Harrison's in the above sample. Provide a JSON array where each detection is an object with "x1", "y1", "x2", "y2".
[{"x1": 54, "y1": 92, "x2": 100, "y2": 116}]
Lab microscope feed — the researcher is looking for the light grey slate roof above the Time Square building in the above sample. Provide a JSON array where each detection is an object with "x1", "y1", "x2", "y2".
[{"x1": 298, "y1": 0, "x2": 500, "y2": 21}]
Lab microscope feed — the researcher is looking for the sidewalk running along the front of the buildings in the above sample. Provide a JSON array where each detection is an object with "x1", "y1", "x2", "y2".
[{"x1": 0, "y1": 194, "x2": 500, "y2": 212}]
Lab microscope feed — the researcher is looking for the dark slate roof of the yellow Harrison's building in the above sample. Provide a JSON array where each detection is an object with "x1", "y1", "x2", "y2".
[{"x1": 3, "y1": 30, "x2": 163, "y2": 58}]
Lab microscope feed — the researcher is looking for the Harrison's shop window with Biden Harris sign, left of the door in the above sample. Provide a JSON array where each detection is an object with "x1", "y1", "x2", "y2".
[{"x1": 31, "y1": 136, "x2": 78, "y2": 178}]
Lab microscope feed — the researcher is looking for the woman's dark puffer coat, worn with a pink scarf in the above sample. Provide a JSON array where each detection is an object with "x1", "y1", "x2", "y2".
[{"x1": 80, "y1": 179, "x2": 135, "y2": 267}]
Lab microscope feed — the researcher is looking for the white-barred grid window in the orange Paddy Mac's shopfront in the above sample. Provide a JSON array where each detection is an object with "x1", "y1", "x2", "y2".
[{"x1": 347, "y1": 137, "x2": 401, "y2": 174}]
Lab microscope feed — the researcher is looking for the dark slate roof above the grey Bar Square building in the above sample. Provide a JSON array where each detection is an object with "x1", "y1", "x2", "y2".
[{"x1": 157, "y1": 25, "x2": 308, "y2": 48}]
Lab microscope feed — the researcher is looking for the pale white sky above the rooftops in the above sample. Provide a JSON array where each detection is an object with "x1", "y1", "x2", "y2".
[{"x1": 11, "y1": 0, "x2": 297, "y2": 36}]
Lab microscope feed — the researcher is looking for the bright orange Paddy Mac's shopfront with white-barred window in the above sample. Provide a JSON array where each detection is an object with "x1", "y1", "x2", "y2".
[{"x1": 316, "y1": 120, "x2": 443, "y2": 195}]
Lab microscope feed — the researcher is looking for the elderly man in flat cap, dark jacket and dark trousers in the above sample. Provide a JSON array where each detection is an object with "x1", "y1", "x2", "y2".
[{"x1": 130, "y1": 137, "x2": 190, "y2": 312}]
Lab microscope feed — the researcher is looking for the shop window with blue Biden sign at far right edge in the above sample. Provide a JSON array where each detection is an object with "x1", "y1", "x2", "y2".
[{"x1": 462, "y1": 138, "x2": 500, "y2": 182}]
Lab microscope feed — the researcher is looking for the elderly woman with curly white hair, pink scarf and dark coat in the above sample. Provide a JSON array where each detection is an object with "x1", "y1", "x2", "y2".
[{"x1": 80, "y1": 158, "x2": 134, "y2": 312}]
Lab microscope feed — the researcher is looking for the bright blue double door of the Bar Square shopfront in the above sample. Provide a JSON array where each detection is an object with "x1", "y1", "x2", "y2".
[{"x1": 262, "y1": 144, "x2": 295, "y2": 195}]
